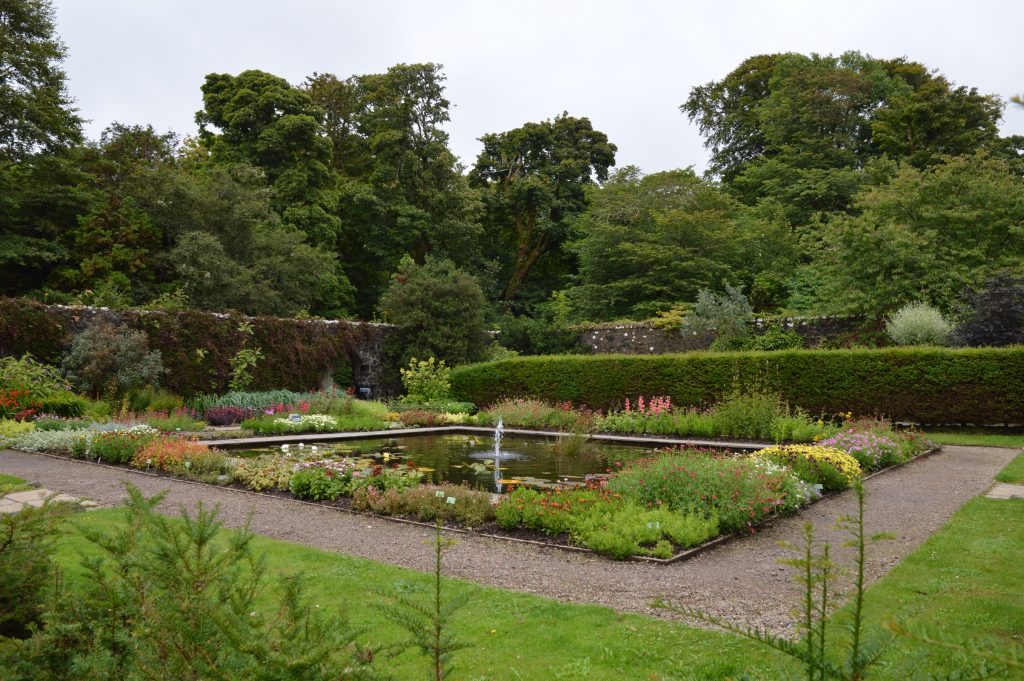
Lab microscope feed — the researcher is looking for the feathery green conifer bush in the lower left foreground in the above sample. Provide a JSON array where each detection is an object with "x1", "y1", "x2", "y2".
[{"x1": 0, "y1": 485, "x2": 378, "y2": 681}]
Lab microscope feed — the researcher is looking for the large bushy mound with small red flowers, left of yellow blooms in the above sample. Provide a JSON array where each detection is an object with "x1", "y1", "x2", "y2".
[{"x1": 608, "y1": 450, "x2": 807, "y2": 531}]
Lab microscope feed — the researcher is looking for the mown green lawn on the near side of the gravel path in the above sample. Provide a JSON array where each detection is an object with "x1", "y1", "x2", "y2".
[{"x1": 44, "y1": 456, "x2": 1024, "y2": 681}]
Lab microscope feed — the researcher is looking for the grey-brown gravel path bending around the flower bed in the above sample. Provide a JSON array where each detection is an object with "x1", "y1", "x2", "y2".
[{"x1": 0, "y1": 446, "x2": 1017, "y2": 632}]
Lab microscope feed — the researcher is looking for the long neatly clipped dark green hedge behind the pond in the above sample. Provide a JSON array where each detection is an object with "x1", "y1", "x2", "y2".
[{"x1": 452, "y1": 346, "x2": 1024, "y2": 424}]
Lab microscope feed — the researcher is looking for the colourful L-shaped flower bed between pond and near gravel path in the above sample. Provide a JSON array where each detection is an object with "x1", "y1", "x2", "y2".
[{"x1": 14, "y1": 417, "x2": 937, "y2": 559}]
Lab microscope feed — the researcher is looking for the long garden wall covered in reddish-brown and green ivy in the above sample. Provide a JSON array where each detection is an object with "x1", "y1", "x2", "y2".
[{"x1": 0, "y1": 298, "x2": 398, "y2": 396}]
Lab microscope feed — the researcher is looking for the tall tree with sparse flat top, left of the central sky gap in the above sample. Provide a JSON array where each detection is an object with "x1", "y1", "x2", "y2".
[{"x1": 304, "y1": 63, "x2": 482, "y2": 313}]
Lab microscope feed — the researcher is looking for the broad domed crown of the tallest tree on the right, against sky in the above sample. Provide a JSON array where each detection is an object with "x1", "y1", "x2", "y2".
[{"x1": 681, "y1": 52, "x2": 1004, "y2": 224}]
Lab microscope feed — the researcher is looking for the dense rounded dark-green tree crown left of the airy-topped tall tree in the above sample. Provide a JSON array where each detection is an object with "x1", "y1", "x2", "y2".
[{"x1": 196, "y1": 71, "x2": 340, "y2": 247}]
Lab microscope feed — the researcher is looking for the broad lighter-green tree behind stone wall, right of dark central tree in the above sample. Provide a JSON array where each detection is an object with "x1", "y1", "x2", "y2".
[{"x1": 567, "y1": 167, "x2": 796, "y2": 321}]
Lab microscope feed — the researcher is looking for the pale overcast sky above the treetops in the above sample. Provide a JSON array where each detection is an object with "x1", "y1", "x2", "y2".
[{"x1": 54, "y1": 0, "x2": 1024, "y2": 172}]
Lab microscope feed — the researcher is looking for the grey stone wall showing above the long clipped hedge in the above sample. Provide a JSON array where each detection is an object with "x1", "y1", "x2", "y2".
[{"x1": 580, "y1": 316, "x2": 862, "y2": 354}]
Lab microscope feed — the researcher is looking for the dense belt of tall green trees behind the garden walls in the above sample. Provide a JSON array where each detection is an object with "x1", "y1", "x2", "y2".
[{"x1": 0, "y1": 6, "x2": 1024, "y2": 346}]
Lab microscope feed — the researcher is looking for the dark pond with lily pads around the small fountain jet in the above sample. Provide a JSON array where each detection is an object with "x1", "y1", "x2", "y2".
[{"x1": 224, "y1": 433, "x2": 667, "y2": 492}]
